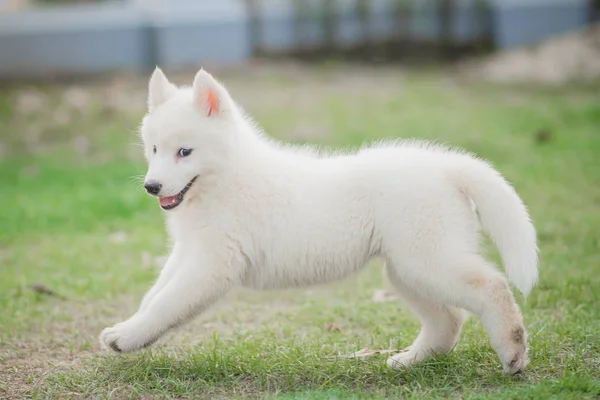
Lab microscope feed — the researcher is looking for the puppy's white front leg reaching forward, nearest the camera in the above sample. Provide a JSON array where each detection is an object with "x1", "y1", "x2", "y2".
[{"x1": 100, "y1": 256, "x2": 234, "y2": 353}]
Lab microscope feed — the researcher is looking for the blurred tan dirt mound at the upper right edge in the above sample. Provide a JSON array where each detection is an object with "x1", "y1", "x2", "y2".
[{"x1": 459, "y1": 24, "x2": 600, "y2": 85}]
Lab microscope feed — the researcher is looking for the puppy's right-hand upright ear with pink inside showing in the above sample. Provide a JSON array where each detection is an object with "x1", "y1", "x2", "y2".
[{"x1": 192, "y1": 69, "x2": 232, "y2": 117}]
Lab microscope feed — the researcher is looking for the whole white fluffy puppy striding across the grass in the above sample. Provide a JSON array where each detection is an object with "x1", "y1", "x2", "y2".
[{"x1": 101, "y1": 70, "x2": 537, "y2": 373}]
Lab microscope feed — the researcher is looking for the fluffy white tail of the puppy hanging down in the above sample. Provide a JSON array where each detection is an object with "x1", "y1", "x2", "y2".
[{"x1": 457, "y1": 159, "x2": 538, "y2": 296}]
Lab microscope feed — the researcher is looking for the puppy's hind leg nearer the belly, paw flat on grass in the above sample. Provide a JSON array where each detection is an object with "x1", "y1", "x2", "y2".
[{"x1": 387, "y1": 264, "x2": 467, "y2": 368}]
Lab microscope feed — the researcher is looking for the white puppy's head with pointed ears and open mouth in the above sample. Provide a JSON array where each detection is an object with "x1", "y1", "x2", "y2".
[{"x1": 140, "y1": 67, "x2": 236, "y2": 210}]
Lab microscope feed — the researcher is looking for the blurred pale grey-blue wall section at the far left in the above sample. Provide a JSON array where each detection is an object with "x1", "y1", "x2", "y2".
[{"x1": 0, "y1": 4, "x2": 148, "y2": 75}]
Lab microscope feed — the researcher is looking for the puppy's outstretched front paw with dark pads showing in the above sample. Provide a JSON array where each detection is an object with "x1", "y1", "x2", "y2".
[{"x1": 100, "y1": 317, "x2": 156, "y2": 353}]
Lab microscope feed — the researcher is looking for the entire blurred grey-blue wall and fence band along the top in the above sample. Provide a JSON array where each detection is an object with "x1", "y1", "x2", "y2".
[{"x1": 0, "y1": 0, "x2": 595, "y2": 78}]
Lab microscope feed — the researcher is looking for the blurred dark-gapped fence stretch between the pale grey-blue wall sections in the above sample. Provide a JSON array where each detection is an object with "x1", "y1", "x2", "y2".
[{"x1": 246, "y1": 0, "x2": 492, "y2": 59}]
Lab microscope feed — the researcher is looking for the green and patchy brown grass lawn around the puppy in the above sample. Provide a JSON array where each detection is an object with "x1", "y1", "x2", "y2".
[{"x1": 0, "y1": 66, "x2": 600, "y2": 399}]
